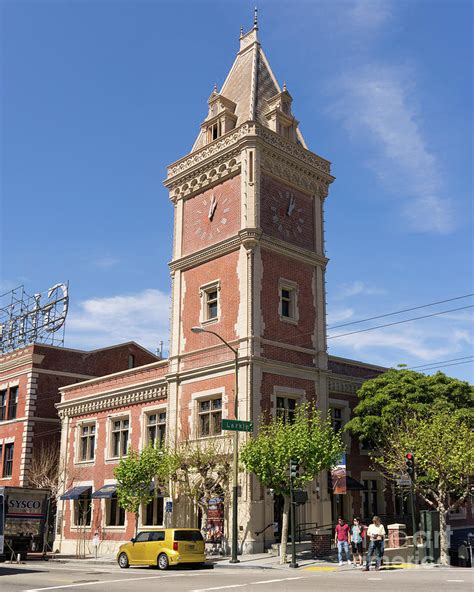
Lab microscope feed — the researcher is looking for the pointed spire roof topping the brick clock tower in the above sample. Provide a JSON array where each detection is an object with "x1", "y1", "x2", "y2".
[{"x1": 192, "y1": 17, "x2": 306, "y2": 151}]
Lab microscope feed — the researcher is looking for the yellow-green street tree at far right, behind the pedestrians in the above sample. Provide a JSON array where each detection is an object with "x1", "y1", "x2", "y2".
[{"x1": 372, "y1": 410, "x2": 474, "y2": 565}]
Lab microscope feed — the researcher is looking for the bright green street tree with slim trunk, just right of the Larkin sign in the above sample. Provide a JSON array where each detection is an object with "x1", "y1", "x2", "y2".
[{"x1": 240, "y1": 403, "x2": 344, "y2": 563}]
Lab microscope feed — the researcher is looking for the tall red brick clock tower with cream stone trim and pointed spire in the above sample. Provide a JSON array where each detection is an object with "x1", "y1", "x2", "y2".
[{"x1": 165, "y1": 23, "x2": 334, "y2": 552}]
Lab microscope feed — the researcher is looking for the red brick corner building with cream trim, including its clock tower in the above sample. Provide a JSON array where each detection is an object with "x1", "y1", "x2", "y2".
[{"x1": 55, "y1": 26, "x2": 388, "y2": 553}]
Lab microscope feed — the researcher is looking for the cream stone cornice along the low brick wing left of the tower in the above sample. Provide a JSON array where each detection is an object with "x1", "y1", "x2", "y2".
[{"x1": 56, "y1": 381, "x2": 168, "y2": 419}]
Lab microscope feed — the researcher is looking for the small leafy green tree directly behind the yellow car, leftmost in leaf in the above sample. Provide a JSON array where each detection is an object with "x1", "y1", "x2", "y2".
[{"x1": 114, "y1": 445, "x2": 176, "y2": 534}]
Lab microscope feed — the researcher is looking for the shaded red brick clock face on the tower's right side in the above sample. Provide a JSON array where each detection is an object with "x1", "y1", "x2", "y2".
[{"x1": 260, "y1": 175, "x2": 315, "y2": 251}]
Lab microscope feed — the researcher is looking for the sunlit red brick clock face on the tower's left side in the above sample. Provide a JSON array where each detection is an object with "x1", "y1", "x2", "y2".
[{"x1": 182, "y1": 175, "x2": 240, "y2": 255}]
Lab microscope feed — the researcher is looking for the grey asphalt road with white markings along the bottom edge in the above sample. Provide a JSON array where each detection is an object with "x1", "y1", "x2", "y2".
[{"x1": 0, "y1": 562, "x2": 474, "y2": 592}]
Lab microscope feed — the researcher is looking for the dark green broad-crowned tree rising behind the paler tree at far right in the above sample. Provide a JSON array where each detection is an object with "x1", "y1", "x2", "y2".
[{"x1": 344, "y1": 368, "x2": 474, "y2": 447}]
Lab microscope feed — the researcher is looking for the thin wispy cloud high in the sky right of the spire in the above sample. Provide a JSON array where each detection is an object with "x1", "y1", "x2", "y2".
[{"x1": 331, "y1": 64, "x2": 453, "y2": 233}]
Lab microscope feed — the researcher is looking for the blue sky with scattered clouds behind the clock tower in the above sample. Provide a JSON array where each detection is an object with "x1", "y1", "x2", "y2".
[{"x1": 1, "y1": 0, "x2": 474, "y2": 381}]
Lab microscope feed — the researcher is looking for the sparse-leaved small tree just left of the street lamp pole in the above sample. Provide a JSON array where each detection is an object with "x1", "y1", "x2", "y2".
[{"x1": 173, "y1": 438, "x2": 232, "y2": 537}]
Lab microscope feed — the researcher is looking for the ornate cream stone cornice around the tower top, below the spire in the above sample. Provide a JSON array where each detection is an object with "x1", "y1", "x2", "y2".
[{"x1": 164, "y1": 122, "x2": 334, "y2": 194}]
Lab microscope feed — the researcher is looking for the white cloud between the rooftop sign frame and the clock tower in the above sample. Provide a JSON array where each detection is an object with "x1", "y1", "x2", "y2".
[{"x1": 66, "y1": 289, "x2": 170, "y2": 351}]
